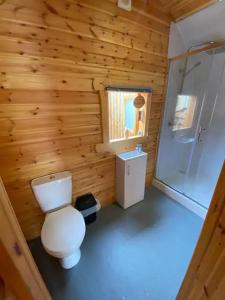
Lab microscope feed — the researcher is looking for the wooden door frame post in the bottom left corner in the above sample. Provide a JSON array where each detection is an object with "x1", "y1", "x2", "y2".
[{"x1": 0, "y1": 177, "x2": 52, "y2": 300}]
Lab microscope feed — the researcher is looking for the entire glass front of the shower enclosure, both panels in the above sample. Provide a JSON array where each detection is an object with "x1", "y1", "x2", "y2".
[{"x1": 156, "y1": 47, "x2": 225, "y2": 210}]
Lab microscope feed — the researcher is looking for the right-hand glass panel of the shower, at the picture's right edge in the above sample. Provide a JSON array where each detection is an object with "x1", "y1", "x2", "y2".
[{"x1": 187, "y1": 48, "x2": 225, "y2": 208}]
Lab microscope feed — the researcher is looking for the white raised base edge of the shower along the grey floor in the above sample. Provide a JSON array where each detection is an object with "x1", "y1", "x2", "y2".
[{"x1": 152, "y1": 178, "x2": 207, "y2": 219}]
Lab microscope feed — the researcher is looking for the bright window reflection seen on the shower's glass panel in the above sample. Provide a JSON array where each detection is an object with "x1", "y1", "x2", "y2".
[{"x1": 172, "y1": 95, "x2": 197, "y2": 131}]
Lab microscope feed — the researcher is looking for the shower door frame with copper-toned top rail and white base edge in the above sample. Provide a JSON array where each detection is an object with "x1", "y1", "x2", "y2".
[{"x1": 152, "y1": 40, "x2": 225, "y2": 219}]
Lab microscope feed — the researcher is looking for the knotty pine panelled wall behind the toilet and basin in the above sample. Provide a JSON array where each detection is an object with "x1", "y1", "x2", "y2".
[{"x1": 0, "y1": 0, "x2": 169, "y2": 239}]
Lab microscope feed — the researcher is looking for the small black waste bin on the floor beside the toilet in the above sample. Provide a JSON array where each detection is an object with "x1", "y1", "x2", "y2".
[{"x1": 75, "y1": 193, "x2": 100, "y2": 224}]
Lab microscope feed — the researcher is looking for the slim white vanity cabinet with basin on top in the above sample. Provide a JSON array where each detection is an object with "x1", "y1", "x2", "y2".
[{"x1": 116, "y1": 150, "x2": 147, "y2": 209}]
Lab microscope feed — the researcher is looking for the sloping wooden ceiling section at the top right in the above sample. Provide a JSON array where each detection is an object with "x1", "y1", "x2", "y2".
[{"x1": 132, "y1": 0, "x2": 218, "y2": 21}]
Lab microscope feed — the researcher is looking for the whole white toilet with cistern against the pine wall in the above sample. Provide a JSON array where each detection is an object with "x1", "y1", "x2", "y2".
[{"x1": 31, "y1": 172, "x2": 86, "y2": 269}]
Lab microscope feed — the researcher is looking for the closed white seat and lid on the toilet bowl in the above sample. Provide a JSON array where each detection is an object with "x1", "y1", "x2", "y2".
[{"x1": 41, "y1": 205, "x2": 85, "y2": 258}]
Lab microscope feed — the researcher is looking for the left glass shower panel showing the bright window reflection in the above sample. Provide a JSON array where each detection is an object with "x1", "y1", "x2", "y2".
[{"x1": 156, "y1": 53, "x2": 212, "y2": 194}]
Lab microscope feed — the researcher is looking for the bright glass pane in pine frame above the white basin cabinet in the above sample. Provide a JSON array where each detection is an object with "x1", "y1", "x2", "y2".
[{"x1": 107, "y1": 91, "x2": 149, "y2": 143}]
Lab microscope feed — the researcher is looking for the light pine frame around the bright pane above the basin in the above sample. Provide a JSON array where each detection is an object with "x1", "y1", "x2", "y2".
[{"x1": 99, "y1": 90, "x2": 152, "y2": 148}]
